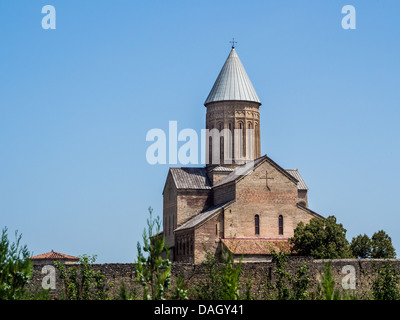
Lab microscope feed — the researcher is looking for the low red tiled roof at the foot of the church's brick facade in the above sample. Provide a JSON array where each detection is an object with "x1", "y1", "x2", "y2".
[{"x1": 221, "y1": 238, "x2": 290, "y2": 254}]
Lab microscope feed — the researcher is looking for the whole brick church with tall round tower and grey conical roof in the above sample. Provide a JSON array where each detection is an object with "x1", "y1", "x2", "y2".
[{"x1": 163, "y1": 46, "x2": 323, "y2": 264}]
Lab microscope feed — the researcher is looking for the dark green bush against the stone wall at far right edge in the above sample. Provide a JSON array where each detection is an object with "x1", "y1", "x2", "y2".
[{"x1": 372, "y1": 262, "x2": 400, "y2": 300}]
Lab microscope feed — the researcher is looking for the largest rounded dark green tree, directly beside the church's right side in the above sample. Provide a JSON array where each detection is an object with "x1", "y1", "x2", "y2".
[{"x1": 289, "y1": 216, "x2": 351, "y2": 259}]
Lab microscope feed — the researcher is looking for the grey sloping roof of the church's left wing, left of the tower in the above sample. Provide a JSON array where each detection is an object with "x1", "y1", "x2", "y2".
[{"x1": 169, "y1": 167, "x2": 211, "y2": 190}]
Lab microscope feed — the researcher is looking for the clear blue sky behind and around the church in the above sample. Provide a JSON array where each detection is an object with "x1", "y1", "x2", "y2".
[{"x1": 0, "y1": 0, "x2": 400, "y2": 263}]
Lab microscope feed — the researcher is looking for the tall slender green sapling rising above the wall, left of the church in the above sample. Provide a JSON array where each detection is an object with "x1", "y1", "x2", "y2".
[{"x1": 135, "y1": 207, "x2": 171, "y2": 300}]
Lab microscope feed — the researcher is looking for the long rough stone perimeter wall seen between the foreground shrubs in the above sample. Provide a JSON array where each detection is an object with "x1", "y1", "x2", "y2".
[{"x1": 29, "y1": 257, "x2": 400, "y2": 299}]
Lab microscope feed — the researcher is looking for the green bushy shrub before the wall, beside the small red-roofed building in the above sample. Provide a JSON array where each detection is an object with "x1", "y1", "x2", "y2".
[{"x1": 54, "y1": 255, "x2": 109, "y2": 300}]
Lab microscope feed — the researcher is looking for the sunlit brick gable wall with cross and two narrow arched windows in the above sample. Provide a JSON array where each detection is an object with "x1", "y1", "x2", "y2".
[{"x1": 222, "y1": 162, "x2": 313, "y2": 238}]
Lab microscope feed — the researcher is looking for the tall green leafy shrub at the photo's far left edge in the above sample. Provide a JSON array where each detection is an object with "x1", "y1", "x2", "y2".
[{"x1": 0, "y1": 227, "x2": 33, "y2": 300}]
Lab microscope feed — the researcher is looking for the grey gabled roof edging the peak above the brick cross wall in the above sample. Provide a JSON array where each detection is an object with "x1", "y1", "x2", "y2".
[{"x1": 213, "y1": 155, "x2": 299, "y2": 187}]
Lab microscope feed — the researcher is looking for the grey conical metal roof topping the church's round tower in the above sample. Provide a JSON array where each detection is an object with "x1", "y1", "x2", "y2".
[{"x1": 204, "y1": 48, "x2": 261, "y2": 105}]
